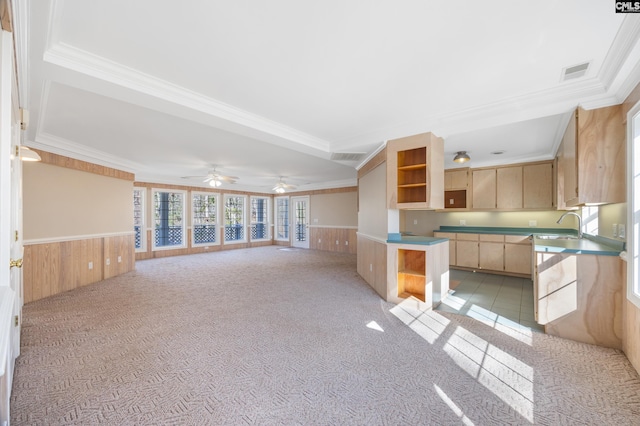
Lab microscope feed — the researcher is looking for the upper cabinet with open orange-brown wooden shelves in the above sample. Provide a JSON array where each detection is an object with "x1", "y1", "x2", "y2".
[{"x1": 387, "y1": 133, "x2": 444, "y2": 209}]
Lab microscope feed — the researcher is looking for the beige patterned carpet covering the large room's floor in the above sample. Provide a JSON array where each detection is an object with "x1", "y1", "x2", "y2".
[{"x1": 11, "y1": 247, "x2": 640, "y2": 425}]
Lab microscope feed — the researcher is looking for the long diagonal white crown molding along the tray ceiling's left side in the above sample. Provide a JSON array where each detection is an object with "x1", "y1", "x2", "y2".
[{"x1": 43, "y1": 43, "x2": 330, "y2": 152}]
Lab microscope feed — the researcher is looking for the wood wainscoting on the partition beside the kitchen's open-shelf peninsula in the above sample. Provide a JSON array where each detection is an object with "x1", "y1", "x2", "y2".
[{"x1": 357, "y1": 234, "x2": 387, "y2": 300}]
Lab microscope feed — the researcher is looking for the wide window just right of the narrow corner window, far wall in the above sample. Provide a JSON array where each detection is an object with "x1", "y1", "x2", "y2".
[{"x1": 153, "y1": 189, "x2": 186, "y2": 249}]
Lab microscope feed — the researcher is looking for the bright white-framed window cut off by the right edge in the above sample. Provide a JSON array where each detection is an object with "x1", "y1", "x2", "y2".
[{"x1": 627, "y1": 103, "x2": 640, "y2": 308}]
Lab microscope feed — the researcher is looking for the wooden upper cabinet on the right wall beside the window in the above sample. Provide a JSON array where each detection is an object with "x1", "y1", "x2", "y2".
[{"x1": 557, "y1": 105, "x2": 626, "y2": 208}]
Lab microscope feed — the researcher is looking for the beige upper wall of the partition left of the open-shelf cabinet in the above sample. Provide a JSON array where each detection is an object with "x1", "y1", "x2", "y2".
[{"x1": 358, "y1": 163, "x2": 388, "y2": 240}]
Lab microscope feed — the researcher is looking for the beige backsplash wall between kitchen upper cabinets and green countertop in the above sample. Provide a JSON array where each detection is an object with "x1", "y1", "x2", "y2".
[{"x1": 401, "y1": 210, "x2": 577, "y2": 236}]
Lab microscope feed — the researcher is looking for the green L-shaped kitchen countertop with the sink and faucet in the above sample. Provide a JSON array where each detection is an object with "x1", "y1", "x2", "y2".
[{"x1": 434, "y1": 226, "x2": 625, "y2": 256}]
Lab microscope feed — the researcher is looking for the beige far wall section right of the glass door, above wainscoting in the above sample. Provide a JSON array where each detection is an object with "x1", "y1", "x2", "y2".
[{"x1": 309, "y1": 191, "x2": 358, "y2": 227}]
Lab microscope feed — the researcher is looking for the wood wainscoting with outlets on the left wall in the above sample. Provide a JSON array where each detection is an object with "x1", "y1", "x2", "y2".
[{"x1": 23, "y1": 233, "x2": 135, "y2": 303}]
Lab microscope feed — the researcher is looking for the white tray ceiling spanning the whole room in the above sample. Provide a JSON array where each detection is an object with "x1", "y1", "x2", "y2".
[{"x1": 14, "y1": 0, "x2": 640, "y2": 192}]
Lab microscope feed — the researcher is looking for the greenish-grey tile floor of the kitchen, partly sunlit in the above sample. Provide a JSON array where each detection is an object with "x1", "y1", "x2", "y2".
[{"x1": 436, "y1": 269, "x2": 544, "y2": 331}]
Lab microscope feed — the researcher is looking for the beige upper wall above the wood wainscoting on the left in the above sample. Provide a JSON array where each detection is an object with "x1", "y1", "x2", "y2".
[{"x1": 23, "y1": 163, "x2": 133, "y2": 241}]
